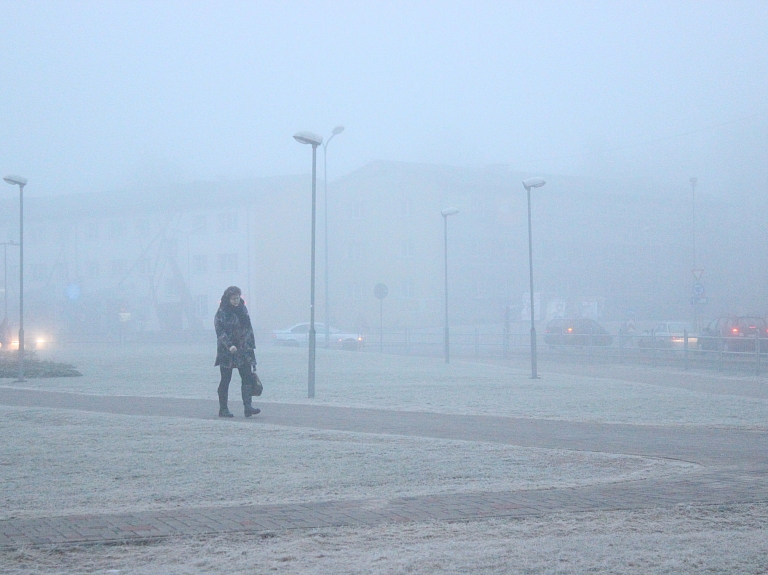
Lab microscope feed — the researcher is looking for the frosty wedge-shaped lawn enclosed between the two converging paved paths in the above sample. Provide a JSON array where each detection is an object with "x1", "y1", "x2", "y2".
[{"x1": 0, "y1": 406, "x2": 696, "y2": 519}]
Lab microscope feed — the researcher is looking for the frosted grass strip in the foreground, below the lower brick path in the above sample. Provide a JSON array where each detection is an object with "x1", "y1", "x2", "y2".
[{"x1": 0, "y1": 505, "x2": 768, "y2": 575}]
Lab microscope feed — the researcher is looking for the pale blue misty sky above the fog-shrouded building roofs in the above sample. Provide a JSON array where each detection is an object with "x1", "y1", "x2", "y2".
[{"x1": 0, "y1": 0, "x2": 768, "y2": 195}]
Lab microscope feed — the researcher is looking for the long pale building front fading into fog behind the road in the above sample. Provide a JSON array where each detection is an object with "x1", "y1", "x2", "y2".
[{"x1": 0, "y1": 162, "x2": 768, "y2": 337}]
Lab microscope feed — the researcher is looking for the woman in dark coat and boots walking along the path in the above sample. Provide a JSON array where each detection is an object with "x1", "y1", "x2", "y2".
[{"x1": 213, "y1": 286, "x2": 261, "y2": 417}]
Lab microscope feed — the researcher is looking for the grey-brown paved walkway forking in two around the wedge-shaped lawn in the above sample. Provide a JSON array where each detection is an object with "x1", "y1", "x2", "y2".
[{"x1": 0, "y1": 387, "x2": 768, "y2": 547}]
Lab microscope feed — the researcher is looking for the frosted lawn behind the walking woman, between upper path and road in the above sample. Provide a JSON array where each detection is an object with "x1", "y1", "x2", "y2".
[{"x1": 22, "y1": 344, "x2": 768, "y2": 427}]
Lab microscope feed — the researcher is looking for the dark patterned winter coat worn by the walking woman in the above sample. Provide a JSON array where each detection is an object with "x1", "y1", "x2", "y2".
[{"x1": 213, "y1": 299, "x2": 256, "y2": 369}]
